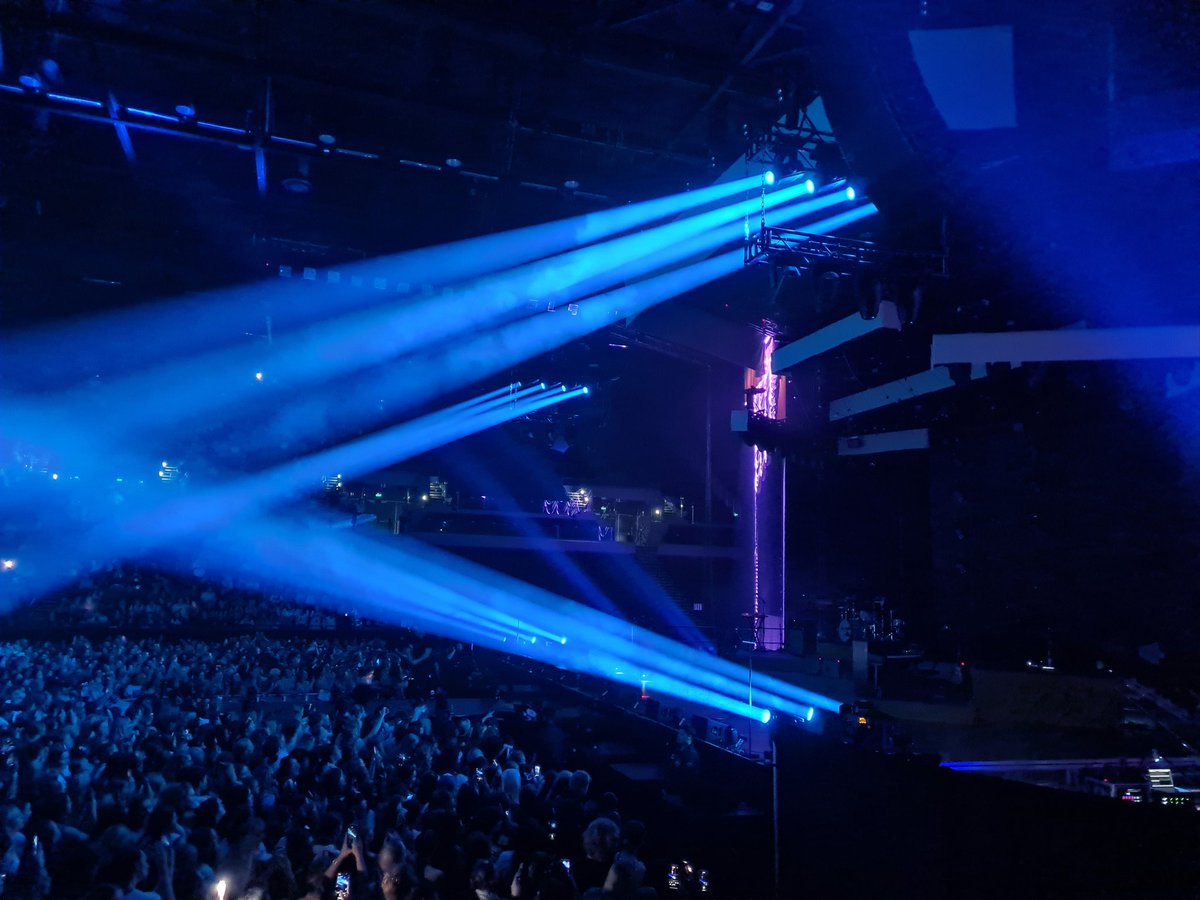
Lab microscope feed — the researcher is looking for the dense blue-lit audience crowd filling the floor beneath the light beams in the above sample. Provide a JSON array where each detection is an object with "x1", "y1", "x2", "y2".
[{"x1": 0, "y1": 571, "x2": 655, "y2": 900}]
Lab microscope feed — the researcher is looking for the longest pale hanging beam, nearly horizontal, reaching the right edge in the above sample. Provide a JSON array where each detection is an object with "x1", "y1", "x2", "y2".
[{"x1": 931, "y1": 325, "x2": 1200, "y2": 366}]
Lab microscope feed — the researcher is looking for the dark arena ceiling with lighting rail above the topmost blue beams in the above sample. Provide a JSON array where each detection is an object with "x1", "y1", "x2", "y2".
[{"x1": 0, "y1": 0, "x2": 812, "y2": 322}]
